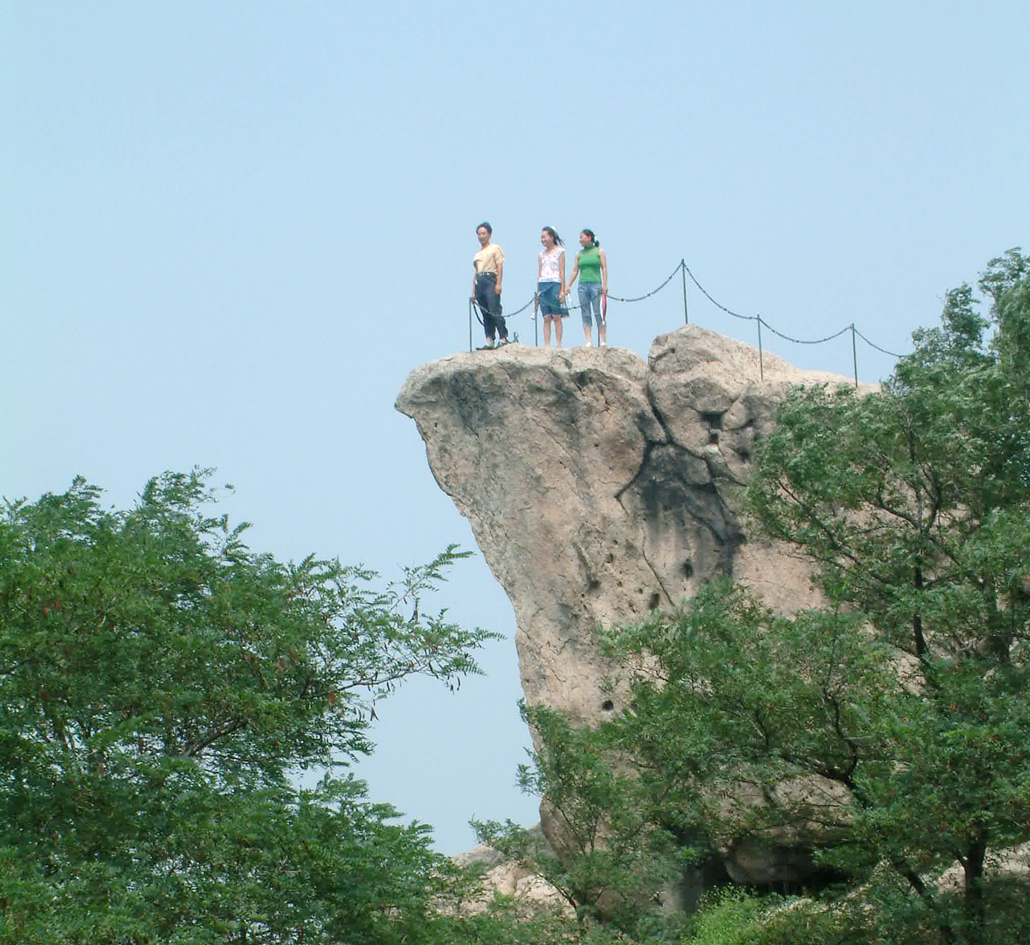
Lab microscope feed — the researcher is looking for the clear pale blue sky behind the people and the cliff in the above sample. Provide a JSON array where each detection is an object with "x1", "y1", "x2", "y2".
[{"x1": 0, "y1": 0, "x2": 1030, "y2": 853}]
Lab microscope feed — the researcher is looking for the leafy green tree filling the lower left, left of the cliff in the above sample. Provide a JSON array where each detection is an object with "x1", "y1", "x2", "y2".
[{"x1": 0, "y1": 472, "x2": 495, "y2": 945}]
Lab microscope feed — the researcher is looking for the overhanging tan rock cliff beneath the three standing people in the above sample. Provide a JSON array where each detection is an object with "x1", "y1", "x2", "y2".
[{"x1": 397, "y1": 327, "x2": 848, "y2": 722}]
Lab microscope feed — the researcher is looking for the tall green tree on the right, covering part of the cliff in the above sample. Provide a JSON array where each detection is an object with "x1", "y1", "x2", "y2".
[{"x1": 609, "y1": 250, "x2": 1030, "y2": 942}]
